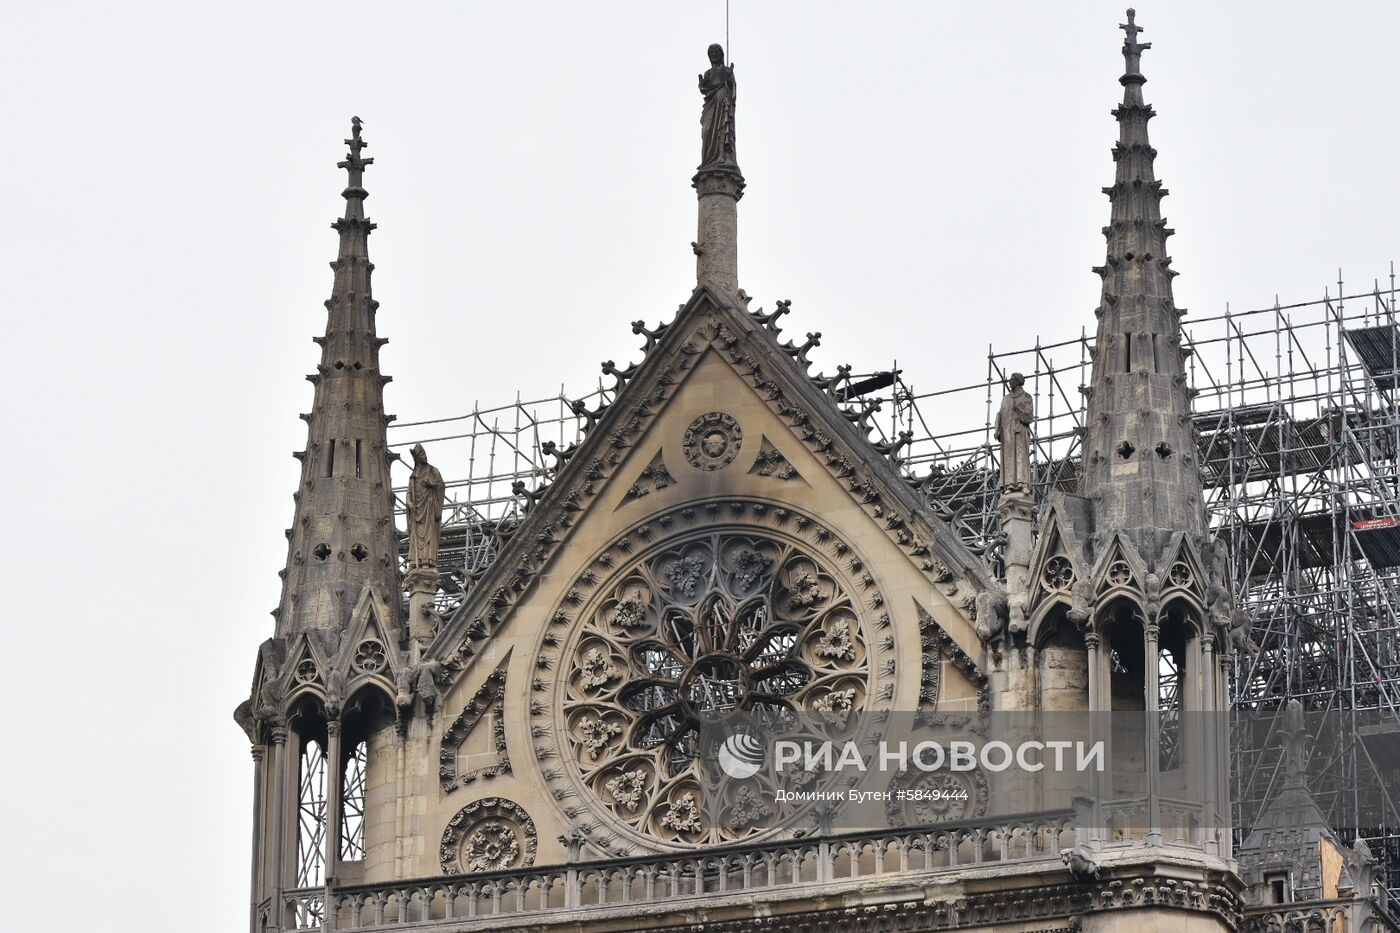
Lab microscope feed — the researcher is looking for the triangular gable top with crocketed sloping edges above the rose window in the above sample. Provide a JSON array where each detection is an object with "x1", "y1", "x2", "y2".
[{"x1": 428, "y1": 287, "x2": 1000, "y2": 682}]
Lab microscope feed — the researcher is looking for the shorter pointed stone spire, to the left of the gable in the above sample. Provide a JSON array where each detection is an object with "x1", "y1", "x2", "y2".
[{"x1": 276, "y1": 116, "x2": 398, "y2": 636}]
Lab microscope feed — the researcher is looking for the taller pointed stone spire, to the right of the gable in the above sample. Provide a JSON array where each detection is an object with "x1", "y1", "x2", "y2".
[{"x1": 1081, "y1": 10, "x2": 1205, "y2": 535}]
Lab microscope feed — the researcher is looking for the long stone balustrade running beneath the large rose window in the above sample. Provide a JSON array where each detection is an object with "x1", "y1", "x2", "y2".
[{"x1": 284, "y1": 810, "x2": 1075, "y2": 930}]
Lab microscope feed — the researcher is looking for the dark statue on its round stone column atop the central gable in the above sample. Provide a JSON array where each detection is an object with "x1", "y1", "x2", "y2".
[{"x1": 690, "y1": 43, "x2": 743, "y2": 298}]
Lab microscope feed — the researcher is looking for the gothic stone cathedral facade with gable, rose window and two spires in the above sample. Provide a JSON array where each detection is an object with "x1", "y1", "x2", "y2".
[{"x1": 237, "y1": 10, "x2": 1271, "y2": 933}]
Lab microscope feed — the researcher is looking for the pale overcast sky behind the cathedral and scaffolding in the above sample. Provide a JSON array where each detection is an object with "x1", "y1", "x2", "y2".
[{"x1": 0, "y1": 0, "x2": 1400, "y2": 930}]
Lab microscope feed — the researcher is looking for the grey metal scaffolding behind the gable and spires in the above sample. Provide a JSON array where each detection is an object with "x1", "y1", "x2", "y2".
[{"x1": 391, "y1": 270, "x2": 1400, "y2": 885}]
